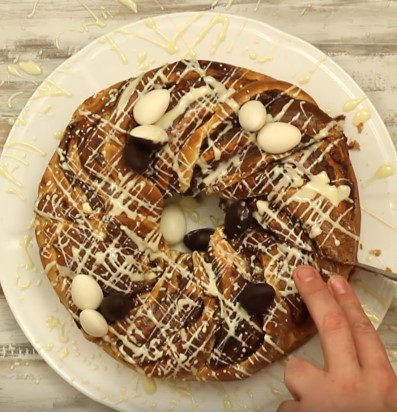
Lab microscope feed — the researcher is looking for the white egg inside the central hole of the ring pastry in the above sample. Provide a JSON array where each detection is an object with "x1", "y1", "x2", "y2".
[{"x1": 160, "y1": 203, "x2": 186, "y2": 245}]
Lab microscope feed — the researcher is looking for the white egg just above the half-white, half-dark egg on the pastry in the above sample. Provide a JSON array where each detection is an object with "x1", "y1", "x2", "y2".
[{"x1": 132, "y1": 89, "x2": 171, "y2": 125}]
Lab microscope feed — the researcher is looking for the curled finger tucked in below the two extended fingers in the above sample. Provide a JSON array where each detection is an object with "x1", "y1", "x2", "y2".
[{"x1": 284, "y1": 358, "x2": 324, "y2": 401}]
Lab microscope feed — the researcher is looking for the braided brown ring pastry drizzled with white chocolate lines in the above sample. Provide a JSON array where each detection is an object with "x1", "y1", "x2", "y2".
[{"x1": 35, "y1": 61, "x2": 360, "y2": 380}]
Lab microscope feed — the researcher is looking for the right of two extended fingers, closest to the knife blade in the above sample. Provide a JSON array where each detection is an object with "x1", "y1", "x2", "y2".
[{"x1": 328, "y1": 275, "x2": 391, "y2": 368}]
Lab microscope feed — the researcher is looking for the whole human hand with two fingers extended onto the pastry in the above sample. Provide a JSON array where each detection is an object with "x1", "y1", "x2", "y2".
[{"x1": 277, "y1": 266, "x2": 397, "y2": 412}]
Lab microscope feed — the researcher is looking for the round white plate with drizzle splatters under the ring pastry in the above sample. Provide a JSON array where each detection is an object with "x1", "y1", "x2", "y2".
[{"x1": 0, "y1": 13, "x2": 397, "y2": 412}]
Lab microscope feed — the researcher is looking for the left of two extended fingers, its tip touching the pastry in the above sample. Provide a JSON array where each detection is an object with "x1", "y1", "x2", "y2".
[{"x1": 294, "y1": 266, "x2": 359, "y2": 373}]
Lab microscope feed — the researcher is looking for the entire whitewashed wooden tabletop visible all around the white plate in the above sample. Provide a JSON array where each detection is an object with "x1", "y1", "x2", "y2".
[{"x1": 0, "y1": 0, "x2": 397, "y2": 412}]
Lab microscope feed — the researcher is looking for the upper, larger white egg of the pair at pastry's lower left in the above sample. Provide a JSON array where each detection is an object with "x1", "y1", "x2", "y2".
[{"x1": 70, "y1": 275, "x2": 103, "y2": 310}]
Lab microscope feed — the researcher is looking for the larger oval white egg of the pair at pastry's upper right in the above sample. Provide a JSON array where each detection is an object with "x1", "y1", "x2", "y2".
[{"x1": 257, "y1": 122, "x2": 302, "y2": 154}]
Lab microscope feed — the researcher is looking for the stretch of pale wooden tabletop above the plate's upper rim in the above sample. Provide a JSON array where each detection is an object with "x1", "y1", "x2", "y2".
[{"x1": 0, "y1": 0, "x2": 397, "y2": 146}]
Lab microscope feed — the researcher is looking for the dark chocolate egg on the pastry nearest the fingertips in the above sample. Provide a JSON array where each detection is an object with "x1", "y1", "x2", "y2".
[{"x1": 237, "y1": 283, "x2": 276, "y2": 315}]
